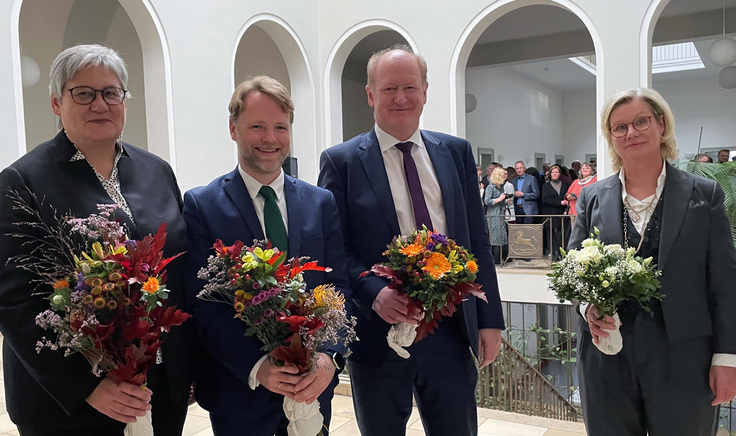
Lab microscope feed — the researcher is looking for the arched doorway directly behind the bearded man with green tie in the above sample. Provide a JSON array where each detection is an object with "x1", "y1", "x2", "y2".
[{"x1": 233, "y1": 14, "x2": 318, "y2": 183}]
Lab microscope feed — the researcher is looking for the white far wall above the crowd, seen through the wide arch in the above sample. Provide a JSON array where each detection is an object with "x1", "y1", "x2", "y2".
[{"x1": 465, "y1": 67, "x2": 567, "y2": 167}]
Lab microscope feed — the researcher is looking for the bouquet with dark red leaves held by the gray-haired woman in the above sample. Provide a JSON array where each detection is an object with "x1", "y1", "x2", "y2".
[{"x1": 9, "y1": 197, "x2": 190, "y2": 436}]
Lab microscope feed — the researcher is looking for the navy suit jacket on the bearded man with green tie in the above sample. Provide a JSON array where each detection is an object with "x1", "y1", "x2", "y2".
[{"x1": 183, "y1": 168, "x2": 351, "y2": 418}]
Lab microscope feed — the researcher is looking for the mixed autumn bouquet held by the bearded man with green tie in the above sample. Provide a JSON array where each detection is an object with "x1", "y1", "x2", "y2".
[{"x1": 197, "y1": 239, "x2": 356, "y2": 436}]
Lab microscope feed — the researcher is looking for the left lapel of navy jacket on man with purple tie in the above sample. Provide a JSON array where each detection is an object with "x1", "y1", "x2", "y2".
[{"x1": 358, "y1": 130, "x2": 401, "y2": 235}]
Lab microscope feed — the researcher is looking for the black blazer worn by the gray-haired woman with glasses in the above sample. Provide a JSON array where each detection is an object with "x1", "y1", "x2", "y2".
[{"x1": 0, "y1": 131, "x2": 193, "y2": 428}]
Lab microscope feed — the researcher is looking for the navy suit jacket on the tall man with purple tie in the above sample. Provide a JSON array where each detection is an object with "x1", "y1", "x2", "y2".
[{"x1": 318, "y1": 130, "x2": 504, "y2": 367}]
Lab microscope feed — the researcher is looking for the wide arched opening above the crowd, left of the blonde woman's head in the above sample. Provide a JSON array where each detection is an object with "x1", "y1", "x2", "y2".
[{"x1": 450, "y1": 0, "x2": 605, "y2": 175}]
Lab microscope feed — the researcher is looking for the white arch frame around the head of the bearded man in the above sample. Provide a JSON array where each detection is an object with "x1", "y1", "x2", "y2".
[{"x1": 230, "y1": 14, "x2": 319, "y2": 182}]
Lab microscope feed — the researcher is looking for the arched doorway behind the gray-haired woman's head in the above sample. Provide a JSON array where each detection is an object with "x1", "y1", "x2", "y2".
[{"x1": 18, "y1": 0, "x2": 175, "y2": 162}]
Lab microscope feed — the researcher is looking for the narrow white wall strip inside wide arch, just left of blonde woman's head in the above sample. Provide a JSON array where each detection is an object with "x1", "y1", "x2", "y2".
[{"x1": 562, "y1": 89, "x2": 598, "y2": 166}]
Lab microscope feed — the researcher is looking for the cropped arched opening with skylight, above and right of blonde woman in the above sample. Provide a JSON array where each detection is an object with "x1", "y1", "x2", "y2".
[{"x1": 642, "y1": 0, "x2": 736, "y2": 162}]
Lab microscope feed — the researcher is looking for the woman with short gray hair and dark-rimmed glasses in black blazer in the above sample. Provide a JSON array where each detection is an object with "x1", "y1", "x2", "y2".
[{"x1": 0, "y1": 44, "x2": 193, "y2": 436}]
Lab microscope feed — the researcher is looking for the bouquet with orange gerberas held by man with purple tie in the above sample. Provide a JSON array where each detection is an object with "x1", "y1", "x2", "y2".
[{"x1": 361, "y1": 226, "x2": 487, "y2": 358}]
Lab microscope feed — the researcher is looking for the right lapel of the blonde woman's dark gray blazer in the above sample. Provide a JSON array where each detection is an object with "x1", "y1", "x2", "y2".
[{"x1": 659, "y1": 163, "x2": 693, "y2": 270}]
